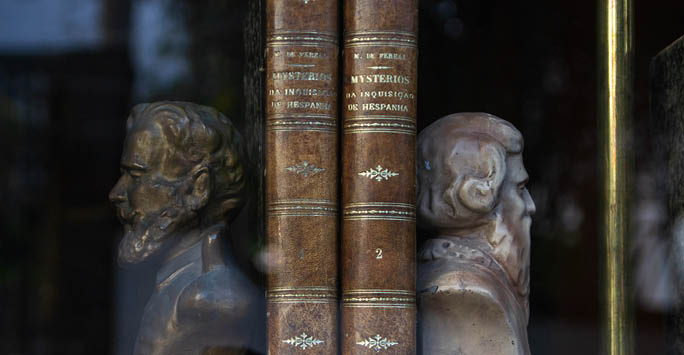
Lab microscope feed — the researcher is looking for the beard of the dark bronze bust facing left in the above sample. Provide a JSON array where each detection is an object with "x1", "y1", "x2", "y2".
[{"x1": 119, "y1": 206, "x2": 185, "y2": 265}]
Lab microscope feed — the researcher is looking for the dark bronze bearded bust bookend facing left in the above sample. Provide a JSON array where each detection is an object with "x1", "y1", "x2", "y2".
[{"x1": 109, "y1": 102, "x2": 259, "y2": 355}]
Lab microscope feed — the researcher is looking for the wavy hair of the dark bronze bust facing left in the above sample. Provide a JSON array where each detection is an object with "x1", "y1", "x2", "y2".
[{"x1": 126, "y1": 101, "x2": 246, "y2": 223}]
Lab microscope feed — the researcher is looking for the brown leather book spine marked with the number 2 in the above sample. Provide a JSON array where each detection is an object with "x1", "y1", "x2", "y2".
[{"x1": 341, "y1": 0, "x2": 418, "y2": 354}]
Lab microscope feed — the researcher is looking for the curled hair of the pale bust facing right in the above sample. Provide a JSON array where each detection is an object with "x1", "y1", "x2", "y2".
[{"x1": 417, "y1": 112, "x2": 523, "y2": 228}]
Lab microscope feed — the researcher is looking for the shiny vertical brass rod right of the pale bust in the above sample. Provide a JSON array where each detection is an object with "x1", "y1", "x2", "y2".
[{"x1": 598, "y1": 0, "x2": 633, "y2": 355}]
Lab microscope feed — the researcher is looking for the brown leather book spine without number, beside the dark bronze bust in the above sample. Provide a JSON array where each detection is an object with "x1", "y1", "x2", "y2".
[{"x1": 265, "y1": 0, "x2": 339, "y2": 355}]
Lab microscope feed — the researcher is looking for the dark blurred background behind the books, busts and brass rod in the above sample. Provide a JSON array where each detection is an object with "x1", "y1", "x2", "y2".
[{"x1": 0, "y1": 0, "x2": 684, "y2": 355}]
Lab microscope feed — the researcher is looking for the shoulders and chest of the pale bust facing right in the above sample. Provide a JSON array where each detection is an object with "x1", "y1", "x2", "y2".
[{"x1": 418, "y1": 239, "x2": 529, "y2": 354}]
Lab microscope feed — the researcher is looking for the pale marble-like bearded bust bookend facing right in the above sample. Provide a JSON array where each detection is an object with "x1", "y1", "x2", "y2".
[{"x1": 417, "y1": 113, "x2": 535, "y2": 355}]
